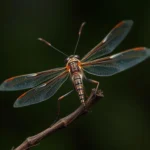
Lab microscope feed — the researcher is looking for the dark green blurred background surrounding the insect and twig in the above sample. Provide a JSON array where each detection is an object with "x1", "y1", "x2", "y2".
[{"x1": 0, "y1": 0, "x2": 150, "y2": 150}]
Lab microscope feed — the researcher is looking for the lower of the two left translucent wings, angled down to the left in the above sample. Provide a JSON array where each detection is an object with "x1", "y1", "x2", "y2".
[{"x1": 14, "y1": 71, "x2": 68, "y2": 107}]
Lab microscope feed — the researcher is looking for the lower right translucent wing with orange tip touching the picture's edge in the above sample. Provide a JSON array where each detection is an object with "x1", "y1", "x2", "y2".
[{"x1": 82, "y1": 47, "x2": 150, "y2": 76}]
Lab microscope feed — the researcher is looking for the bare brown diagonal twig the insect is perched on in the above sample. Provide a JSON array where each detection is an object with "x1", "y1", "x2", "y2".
[{"x1": 14, "y1": 89, "x2": 103, "y2": 150}]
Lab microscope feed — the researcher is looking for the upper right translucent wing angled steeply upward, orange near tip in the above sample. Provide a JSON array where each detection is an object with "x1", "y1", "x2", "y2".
[{"x1": 81, "y1": 20, "x2": 133, "y2": 62}]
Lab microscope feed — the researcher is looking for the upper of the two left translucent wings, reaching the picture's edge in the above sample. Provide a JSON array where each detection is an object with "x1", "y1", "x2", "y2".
[{"x1": 0, "y1": 67, "x2": 65, "y2": 91}]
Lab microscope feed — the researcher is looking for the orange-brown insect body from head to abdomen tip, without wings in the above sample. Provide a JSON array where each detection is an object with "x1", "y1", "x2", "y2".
[{"x1": 67, "y1": 56, "x2": 85, "y2": 103}]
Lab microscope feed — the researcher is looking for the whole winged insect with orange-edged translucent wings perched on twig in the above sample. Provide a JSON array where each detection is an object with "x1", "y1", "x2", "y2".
[{"x1": 0, "y1": 20, "x2": 150, "y2": 107}]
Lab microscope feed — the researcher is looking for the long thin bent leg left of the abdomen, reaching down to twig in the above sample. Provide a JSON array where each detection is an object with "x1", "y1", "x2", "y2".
[{"x1": 53, "y1": 90, "x2": 74, "y2": 124}]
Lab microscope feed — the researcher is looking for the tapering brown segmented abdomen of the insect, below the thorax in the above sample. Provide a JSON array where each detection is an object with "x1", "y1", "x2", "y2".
[{"x1": 72, "y1": 72, "x2": 84, "y2": 102}]
